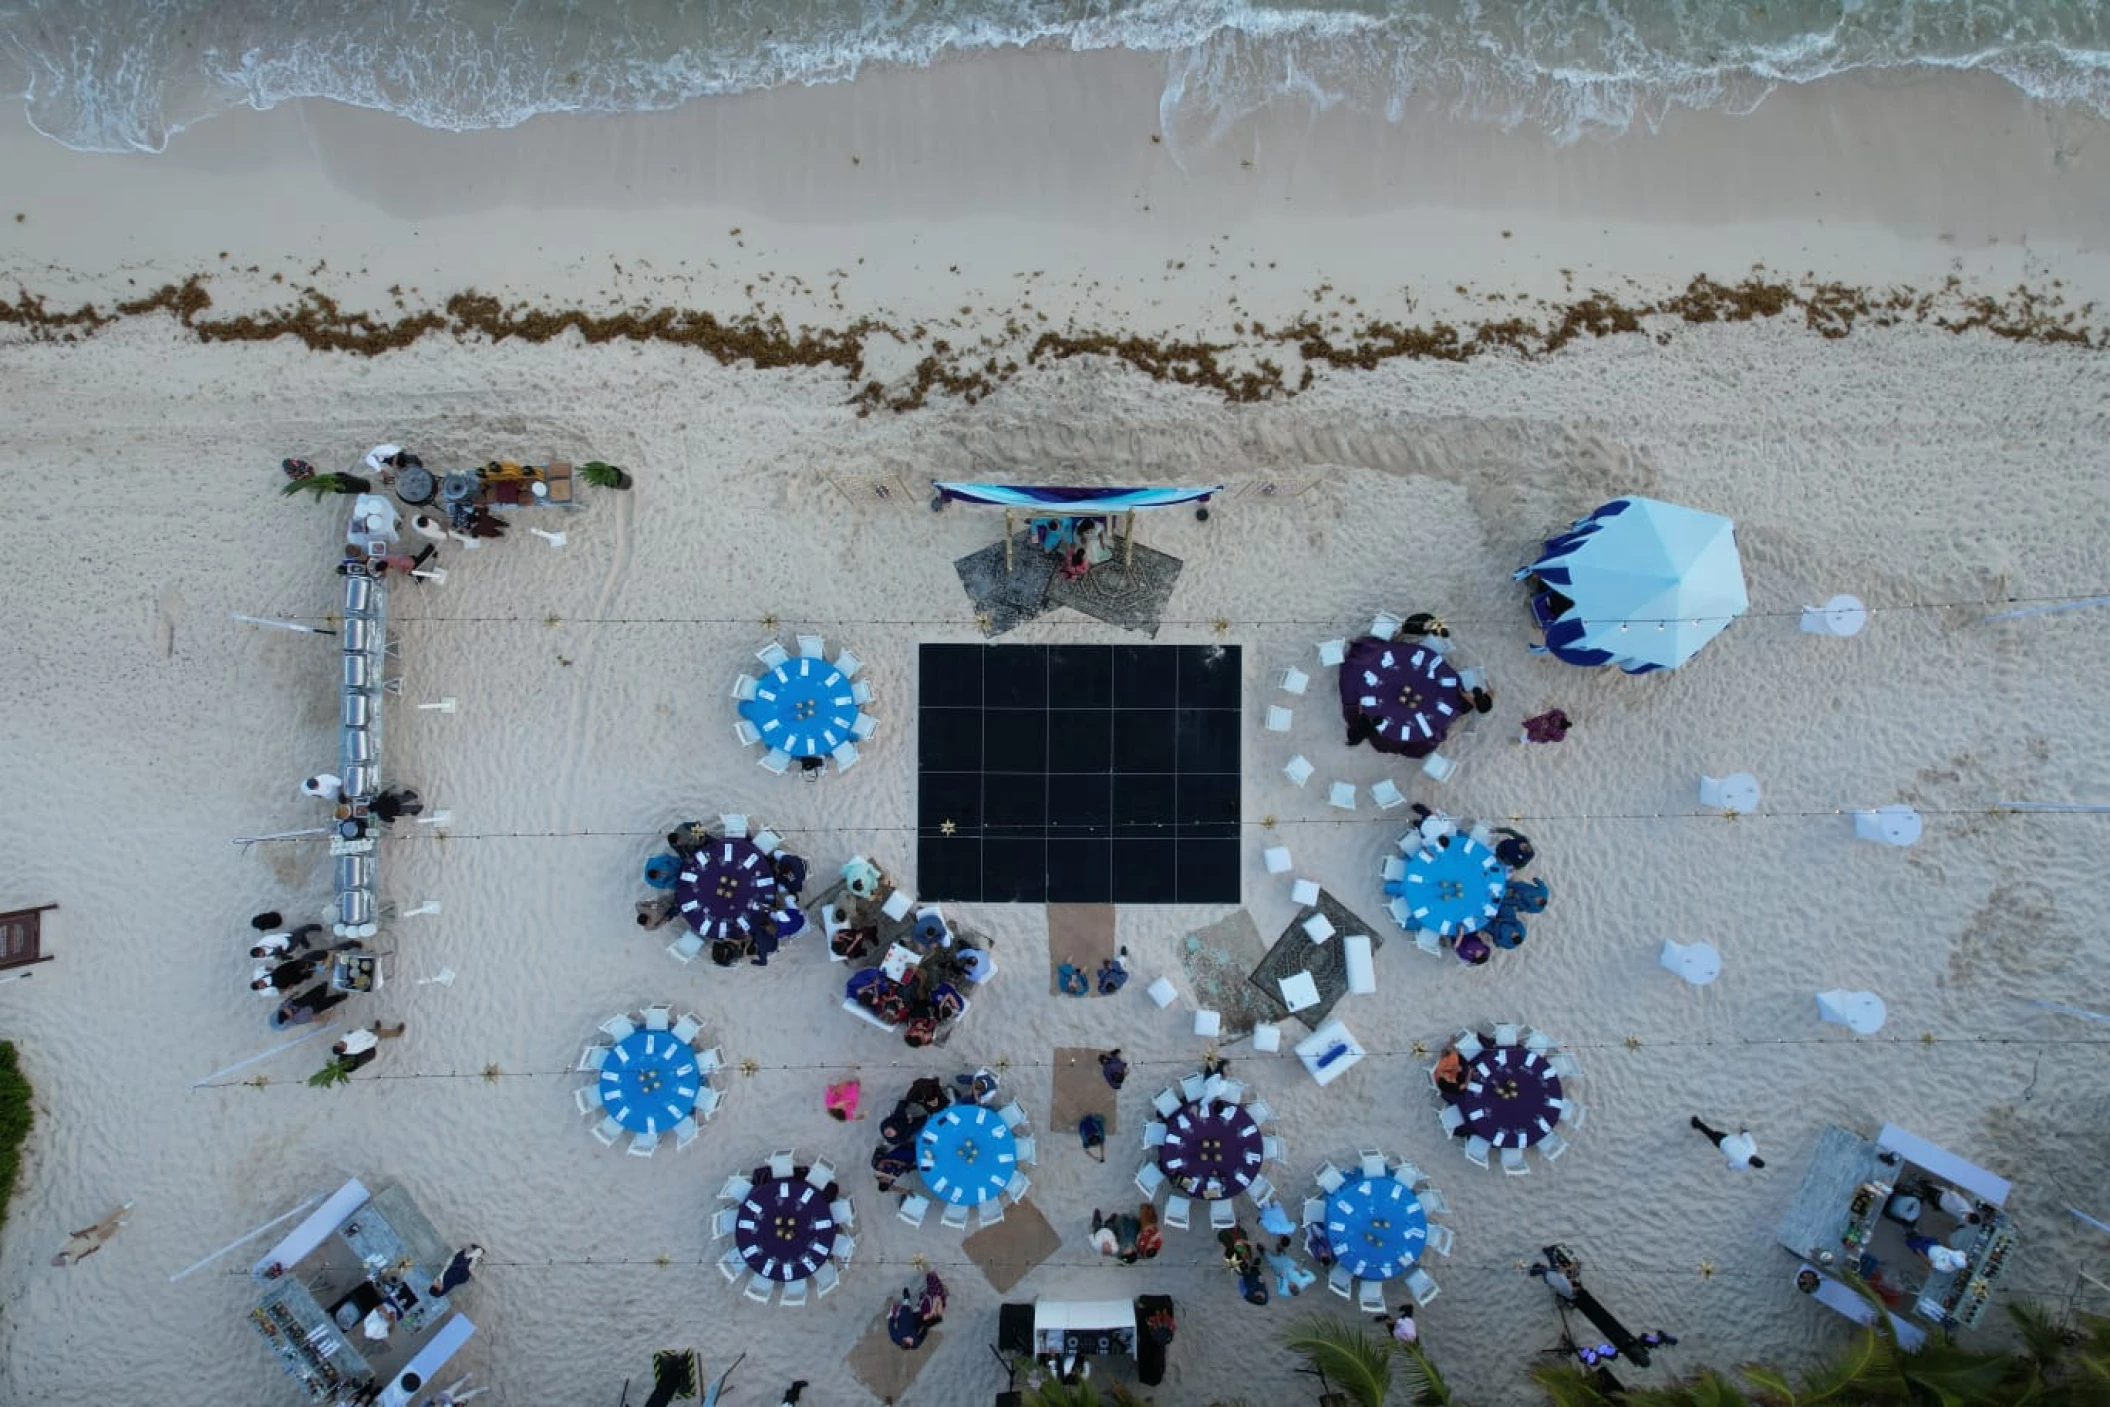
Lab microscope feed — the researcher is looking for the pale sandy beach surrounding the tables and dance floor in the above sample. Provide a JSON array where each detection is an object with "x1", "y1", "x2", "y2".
[{"x1": 0, "y1": 53, "x2": 2110, "y2": 1407}]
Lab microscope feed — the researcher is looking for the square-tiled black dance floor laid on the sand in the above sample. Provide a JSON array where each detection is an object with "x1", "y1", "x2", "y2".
[{"x1": 916, "y1": 645, "x2": 1243, "y2": 903}]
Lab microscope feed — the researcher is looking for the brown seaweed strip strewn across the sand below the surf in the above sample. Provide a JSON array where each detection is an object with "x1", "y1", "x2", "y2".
[{"x1": 0, "y1": 272, "x2": 2110, "y2": 416}]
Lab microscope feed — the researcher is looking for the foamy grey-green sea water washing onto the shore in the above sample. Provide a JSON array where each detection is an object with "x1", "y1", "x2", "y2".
[{"x1": 0, "y1": 0, "x2": 2110, "y2": 152}]
